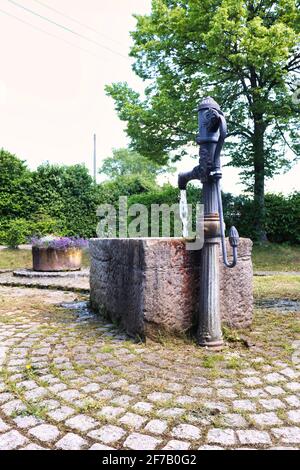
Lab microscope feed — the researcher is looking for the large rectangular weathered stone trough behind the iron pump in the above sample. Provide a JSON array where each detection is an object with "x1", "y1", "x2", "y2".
[{"x1": 90, "y1": 238, "x2": 253, "y2": 338}]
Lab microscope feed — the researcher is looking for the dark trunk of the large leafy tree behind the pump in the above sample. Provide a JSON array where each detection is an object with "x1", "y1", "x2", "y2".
[{"x1": 253, "y1": 116, "x2": 267, "y2": 242}]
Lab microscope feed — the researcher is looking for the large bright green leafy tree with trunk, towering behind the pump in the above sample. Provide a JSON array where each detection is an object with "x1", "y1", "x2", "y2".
[{"x1": 106, "y1": 0, "x2": 300, "y2": 240}]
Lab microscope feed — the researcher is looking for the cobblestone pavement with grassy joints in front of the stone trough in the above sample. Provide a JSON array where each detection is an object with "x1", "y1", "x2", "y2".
[{"x1": 0, "y1": 287, "x2": 300, "y2": 450}]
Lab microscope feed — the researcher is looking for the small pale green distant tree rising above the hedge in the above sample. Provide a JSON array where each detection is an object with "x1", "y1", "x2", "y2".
[{"x1": 99, "y1": 148, "x2": 172, "y2": 182}]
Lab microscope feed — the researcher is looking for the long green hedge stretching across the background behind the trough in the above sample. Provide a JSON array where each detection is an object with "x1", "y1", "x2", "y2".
[{"x1": 0, "y1": 149, "x2": 300, "y2": 246}]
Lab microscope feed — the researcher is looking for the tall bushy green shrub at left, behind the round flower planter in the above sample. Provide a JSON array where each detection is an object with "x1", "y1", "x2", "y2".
[{"x1": 0, "y1": 150, "x2": 100, "y2": 245}]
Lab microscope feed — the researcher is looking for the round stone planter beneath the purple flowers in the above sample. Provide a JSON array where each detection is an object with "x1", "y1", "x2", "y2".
[{"x1": 32, "y1": 246, "x2": 82, "y2": 272}]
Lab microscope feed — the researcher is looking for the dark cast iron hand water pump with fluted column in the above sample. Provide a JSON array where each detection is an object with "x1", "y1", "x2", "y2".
[{"x1": 178, "y1": 97, "x2": 239, "y2": 348}]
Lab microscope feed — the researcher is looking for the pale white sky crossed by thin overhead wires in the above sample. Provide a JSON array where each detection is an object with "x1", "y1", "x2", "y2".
[{"x1": 0, "y1": 0, "x2": 300, "y2": 193}]
